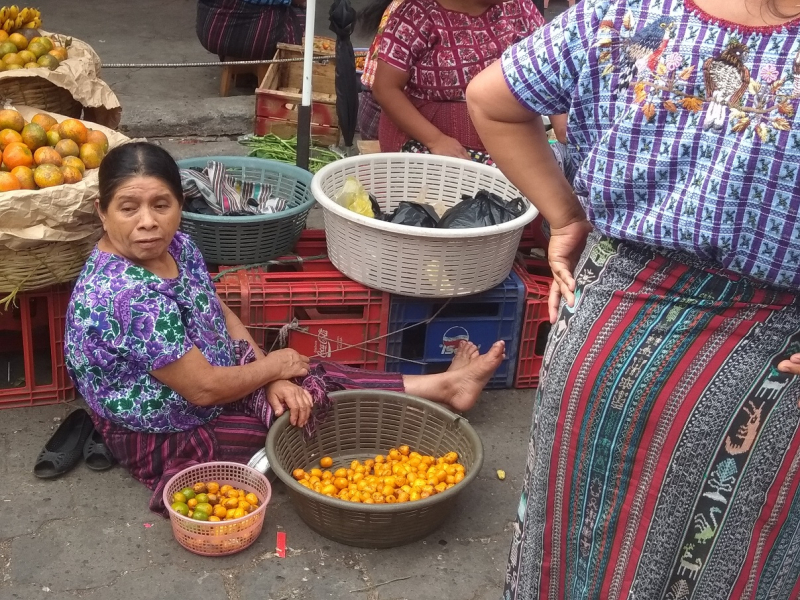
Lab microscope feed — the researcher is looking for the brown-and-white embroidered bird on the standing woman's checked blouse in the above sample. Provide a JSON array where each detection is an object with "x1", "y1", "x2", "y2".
[{"x1": 703, "y1": 40, "x2": 750, "y2": 131}]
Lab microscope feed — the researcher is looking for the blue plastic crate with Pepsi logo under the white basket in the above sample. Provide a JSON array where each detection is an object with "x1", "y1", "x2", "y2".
[{"x1": 386, "y1": 273, "x2": 526, "y2": 389}]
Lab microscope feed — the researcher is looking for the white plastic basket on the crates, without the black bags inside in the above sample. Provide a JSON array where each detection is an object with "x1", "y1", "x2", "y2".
[{"x1": 311, "y1": 153, "x2": 538, "y2": 298}]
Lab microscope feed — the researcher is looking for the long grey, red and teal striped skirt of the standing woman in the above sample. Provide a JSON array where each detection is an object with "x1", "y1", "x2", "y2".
[{"x1": 504, "y1": 234, "x2": 800, "y2": 600}]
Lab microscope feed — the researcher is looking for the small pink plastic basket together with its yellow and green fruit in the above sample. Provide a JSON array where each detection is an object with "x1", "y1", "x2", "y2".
[{"x1": 163, "y1": 461, "x2": 272, "y2": 556}]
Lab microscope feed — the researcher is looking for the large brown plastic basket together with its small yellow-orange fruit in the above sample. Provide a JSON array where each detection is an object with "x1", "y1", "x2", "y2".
[{"x1": 266, "y1": 390, "x2": 483, "y2": 548}]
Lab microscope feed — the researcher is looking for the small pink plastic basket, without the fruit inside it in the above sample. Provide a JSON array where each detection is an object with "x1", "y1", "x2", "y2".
[{"x1": 164, "y1": 462, "x2": 272, "y2": 556}]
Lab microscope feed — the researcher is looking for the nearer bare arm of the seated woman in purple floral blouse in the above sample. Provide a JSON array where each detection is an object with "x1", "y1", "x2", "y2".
[{"x1": 150, "y1": 346, "x2": 308, "y2": 406}]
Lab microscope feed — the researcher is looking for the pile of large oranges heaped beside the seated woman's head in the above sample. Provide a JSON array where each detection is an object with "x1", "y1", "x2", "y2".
[{"x1": 0, "y1": 109, "x2": 108, "y2": 192}]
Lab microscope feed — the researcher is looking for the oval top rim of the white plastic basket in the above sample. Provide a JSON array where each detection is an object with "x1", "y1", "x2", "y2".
[{"x1": 311, "y1": 152, "x2": 539, "y2": 238}]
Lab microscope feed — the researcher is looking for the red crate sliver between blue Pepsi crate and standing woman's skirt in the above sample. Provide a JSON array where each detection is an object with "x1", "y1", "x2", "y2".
[{"x1": 514, "y1": 255, "x2": 552, "y2": 388}]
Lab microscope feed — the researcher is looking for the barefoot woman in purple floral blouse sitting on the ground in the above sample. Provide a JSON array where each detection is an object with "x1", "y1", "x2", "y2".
[{"x1": 65, "y1": 143, "x2": 504, "y2": 514}]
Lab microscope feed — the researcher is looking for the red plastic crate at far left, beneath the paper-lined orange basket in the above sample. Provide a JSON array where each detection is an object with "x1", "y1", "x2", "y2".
[{"x1": 0, "y1": 285, "x2": 75, "y2": 408}]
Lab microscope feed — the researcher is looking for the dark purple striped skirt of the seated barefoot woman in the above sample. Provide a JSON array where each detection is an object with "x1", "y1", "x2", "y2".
[{"x1": 90, "y1": 354, "x2": 405, "y2": 516}]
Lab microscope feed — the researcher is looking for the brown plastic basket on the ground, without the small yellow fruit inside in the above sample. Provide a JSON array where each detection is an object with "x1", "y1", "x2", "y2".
[{"x1": 267, "y1": 390, "x2": 483, "y2": 548}]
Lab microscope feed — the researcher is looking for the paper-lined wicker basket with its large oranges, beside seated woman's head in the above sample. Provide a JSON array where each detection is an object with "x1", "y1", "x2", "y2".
[{"x1": 0, "y1": 106, "x2": 129, "y2": 303}]
